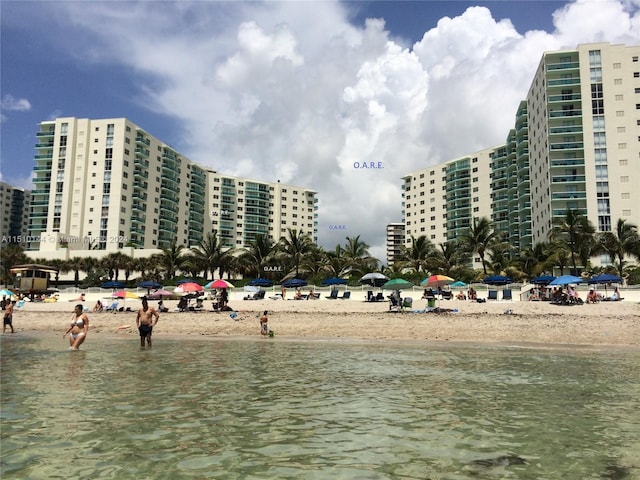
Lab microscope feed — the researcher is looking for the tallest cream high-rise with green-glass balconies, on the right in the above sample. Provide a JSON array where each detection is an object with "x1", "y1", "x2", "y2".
[{"x1": 403, "y1": 43, "x2": 640, "y2": 262}]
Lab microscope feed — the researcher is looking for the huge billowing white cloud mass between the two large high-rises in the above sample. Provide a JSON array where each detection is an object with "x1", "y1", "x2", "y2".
[{"x1": 17, "y1": 0, "x2": 640, "y2": 263}]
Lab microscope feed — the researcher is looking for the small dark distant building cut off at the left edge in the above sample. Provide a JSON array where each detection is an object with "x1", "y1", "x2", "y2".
[{"x1": 0, "y1": 182, "x2": 31, "y2": 248}]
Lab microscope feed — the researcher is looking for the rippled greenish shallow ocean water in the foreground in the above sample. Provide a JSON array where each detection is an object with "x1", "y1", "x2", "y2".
[{"x1": 0, "y1": 335, "x2": 640, "y2": 480}]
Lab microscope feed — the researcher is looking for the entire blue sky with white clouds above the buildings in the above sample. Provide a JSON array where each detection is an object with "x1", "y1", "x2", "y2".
[{"x1": 0, "y1": 0, "x2": 640, "y2": 264}]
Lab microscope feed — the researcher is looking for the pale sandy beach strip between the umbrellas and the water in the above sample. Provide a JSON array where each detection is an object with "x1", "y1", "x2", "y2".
[{"x1": 3, "y1": 290, "x2": 640, "y2": 347}]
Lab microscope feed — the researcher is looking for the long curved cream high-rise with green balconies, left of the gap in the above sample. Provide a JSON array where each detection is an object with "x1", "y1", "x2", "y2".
[{"x1": 29, "y1": 117, "x2": 317, "y2": 252}]
